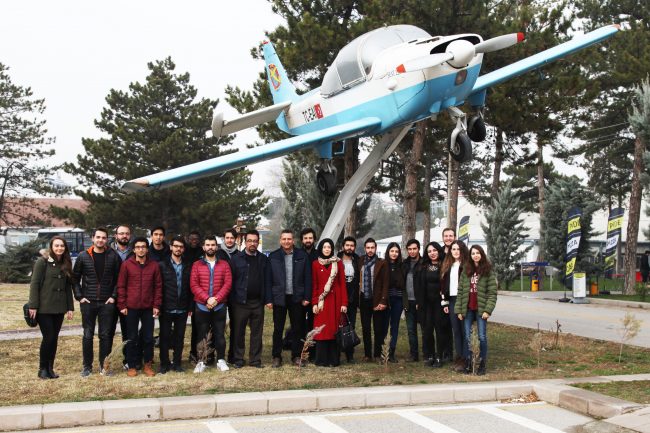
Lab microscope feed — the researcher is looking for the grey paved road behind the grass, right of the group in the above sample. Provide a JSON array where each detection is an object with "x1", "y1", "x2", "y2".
[{"x1": 490, "y1": 292, "x2": 650, "y2": 347}]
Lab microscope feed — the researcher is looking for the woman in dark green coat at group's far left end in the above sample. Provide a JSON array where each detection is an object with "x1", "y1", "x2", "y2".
[{"x1": 29, "y1": 236, "x2": 74, "y2": 379}]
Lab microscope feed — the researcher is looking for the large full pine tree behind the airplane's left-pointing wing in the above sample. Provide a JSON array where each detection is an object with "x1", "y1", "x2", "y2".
[{"x1": 58, "y1": 58, "x2": 266, "y2": 233}]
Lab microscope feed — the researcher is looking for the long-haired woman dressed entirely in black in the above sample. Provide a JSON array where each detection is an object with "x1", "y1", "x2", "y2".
[{"x1": 415, "y1": 242, "x2": 447, "y2": 368}]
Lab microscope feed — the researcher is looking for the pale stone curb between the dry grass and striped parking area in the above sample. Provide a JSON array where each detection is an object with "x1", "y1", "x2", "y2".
[{"x1": 0, "y1": 374, "x2": 650, "y2": 431}]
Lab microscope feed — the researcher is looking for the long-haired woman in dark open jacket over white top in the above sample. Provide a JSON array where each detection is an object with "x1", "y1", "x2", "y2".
[{"x1": 440, "y1": 241, "x2": 469, "y2": 373}]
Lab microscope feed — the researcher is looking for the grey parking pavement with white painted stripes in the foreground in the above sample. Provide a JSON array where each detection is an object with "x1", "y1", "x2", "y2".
[{"x1": 8, "y1": 402, "x2": 621, "y2": 433}]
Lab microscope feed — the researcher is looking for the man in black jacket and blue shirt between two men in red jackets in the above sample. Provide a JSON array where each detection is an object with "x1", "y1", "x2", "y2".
[{"x1": 159, "y1": 236, "x2": 194, "y2": 374}]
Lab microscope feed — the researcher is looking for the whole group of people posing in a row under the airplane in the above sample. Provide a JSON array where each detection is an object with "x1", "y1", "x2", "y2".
[{"x1": 29, "y1": 225, "x2": 496, "y2": 379}]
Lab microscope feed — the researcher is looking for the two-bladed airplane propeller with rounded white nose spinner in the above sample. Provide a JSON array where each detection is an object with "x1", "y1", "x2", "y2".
[{"x1": 395, "y1": 33, "x2": 524, "y2": 74}]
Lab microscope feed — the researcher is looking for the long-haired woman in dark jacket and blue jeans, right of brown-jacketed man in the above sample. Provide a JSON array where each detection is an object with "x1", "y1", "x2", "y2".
[{"x1": 384, "y1": 242, "x2": 406, "y2": 362}]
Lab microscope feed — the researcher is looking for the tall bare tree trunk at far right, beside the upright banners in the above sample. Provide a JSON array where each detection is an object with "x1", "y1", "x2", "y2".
[{"x1": 623, "y1": 137, "x2": 645, "y2": 295}]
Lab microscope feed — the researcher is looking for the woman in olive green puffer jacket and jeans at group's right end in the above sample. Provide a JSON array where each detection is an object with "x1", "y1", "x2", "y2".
[{"x1": 454, "y1": 245, "x2": 497, "y2": 375}]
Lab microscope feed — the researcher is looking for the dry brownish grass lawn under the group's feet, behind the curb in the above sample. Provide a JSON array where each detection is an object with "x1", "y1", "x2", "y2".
[{"x1": 0, "y1": 307, "x2": 650, "y2": 405}]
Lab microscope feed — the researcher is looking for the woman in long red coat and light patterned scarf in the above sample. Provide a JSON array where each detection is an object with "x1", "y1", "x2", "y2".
[{"x1": 311, "y1": 239, "x2": 348, "y2": 367}]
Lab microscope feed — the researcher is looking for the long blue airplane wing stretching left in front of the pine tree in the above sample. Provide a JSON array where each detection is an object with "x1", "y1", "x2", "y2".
[{"x1": 122, "y1": 117, "x2": 381, "y2": 192}]
